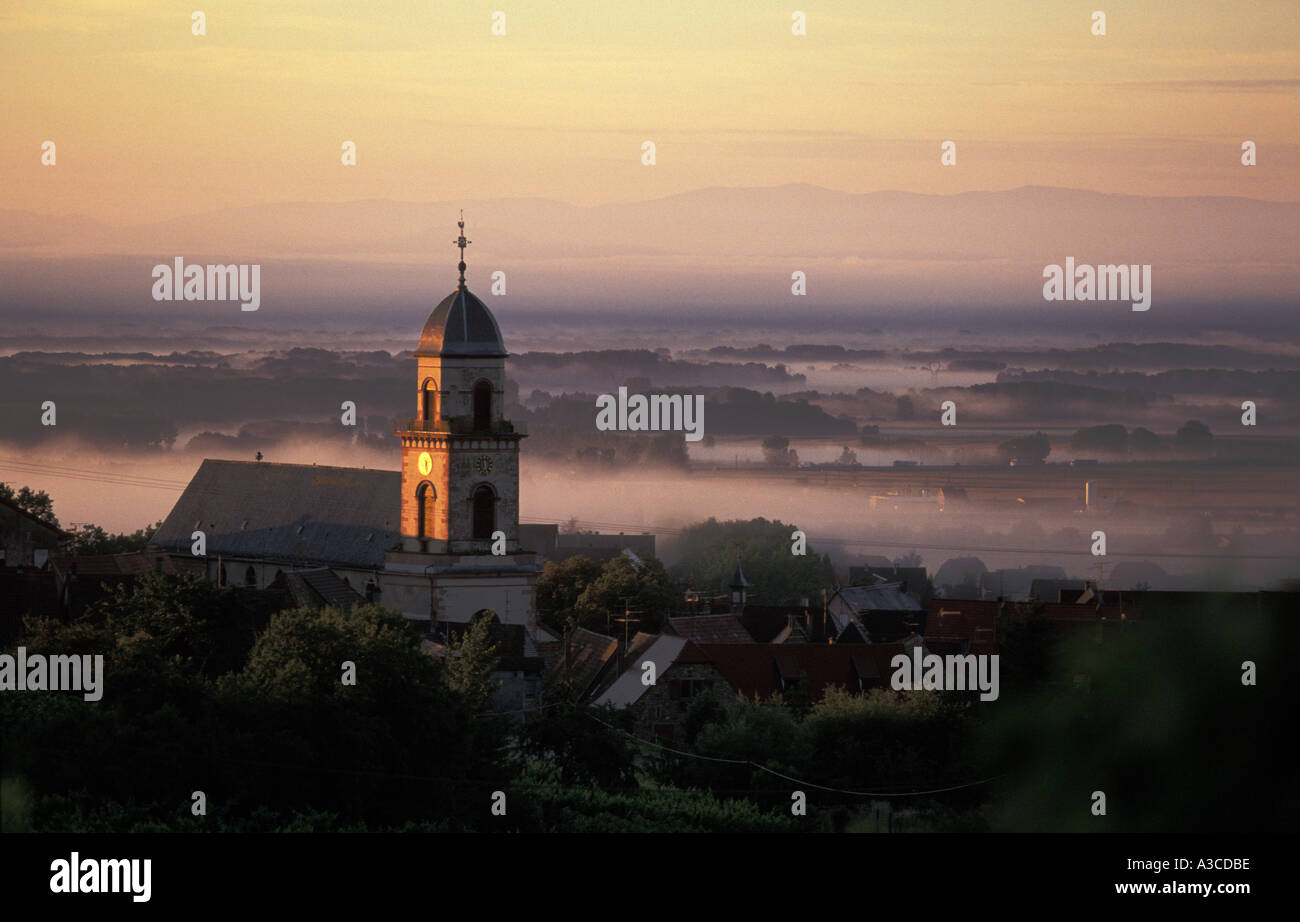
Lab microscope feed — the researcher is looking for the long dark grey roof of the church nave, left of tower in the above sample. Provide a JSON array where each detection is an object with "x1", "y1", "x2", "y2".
[{"x1": 151, "y1": 458, "x2": 402, "y2": 568}]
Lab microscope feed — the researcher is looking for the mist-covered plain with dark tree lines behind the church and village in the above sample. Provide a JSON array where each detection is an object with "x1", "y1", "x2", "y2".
[{"x1": 0, "y1": 330, "x2": 1300, "y2": 588}]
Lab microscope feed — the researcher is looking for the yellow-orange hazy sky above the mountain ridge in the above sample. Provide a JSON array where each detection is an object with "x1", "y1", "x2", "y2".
[{"x1": 0, "y1": 0, "x2": 1300, "y2": 222}]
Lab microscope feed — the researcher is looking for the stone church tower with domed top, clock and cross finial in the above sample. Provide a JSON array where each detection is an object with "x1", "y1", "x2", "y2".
[{"x1": 385, "y1": 216, "x2": 537, "y2": 623}]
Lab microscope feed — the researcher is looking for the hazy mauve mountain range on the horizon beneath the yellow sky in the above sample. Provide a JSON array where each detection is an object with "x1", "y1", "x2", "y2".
[{"x1": 0, "y1": 185, "x2": 1300, "y2": 318}]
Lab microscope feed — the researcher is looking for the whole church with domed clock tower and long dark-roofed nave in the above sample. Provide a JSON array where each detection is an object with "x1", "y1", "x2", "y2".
[{"x1": 152, "y1": 221, "x2": 538, "y2": 629}]
